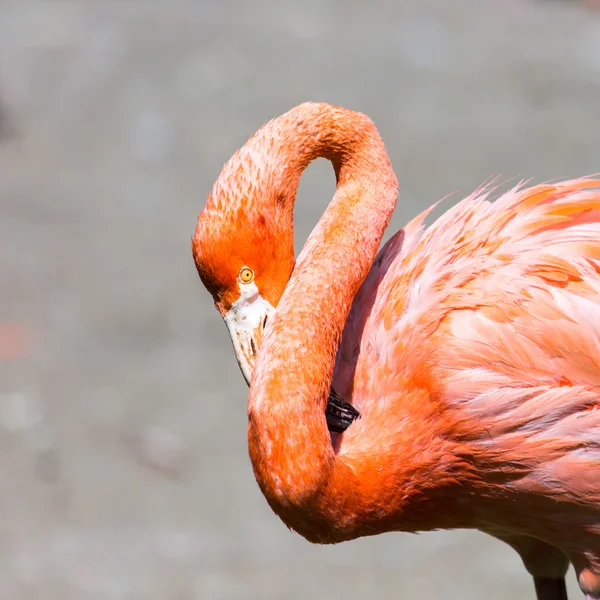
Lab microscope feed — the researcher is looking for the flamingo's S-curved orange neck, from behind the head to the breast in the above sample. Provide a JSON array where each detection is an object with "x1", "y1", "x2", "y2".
[{"x1": 249, "y1": 104, "x2": 397, "y2": 539}]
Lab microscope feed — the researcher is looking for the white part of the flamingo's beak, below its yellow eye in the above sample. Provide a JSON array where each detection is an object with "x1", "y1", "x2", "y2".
[{"x1": 223, "y1": 283, "x2": 275, "y2": 385}]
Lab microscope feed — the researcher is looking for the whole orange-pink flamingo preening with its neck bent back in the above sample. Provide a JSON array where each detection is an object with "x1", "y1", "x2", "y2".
[{"x1": 192, "y1": 102, "x2": 600, "y2": 600}]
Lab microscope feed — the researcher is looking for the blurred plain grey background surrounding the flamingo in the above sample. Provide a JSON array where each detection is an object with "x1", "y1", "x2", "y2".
[{"x1": 0, "y1": 0, "x2": 600, "y2": 600}]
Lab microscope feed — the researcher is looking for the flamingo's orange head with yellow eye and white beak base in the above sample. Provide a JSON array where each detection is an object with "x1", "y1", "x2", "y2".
[{"x1": 192, "y1": 188, "x2": 294, "y2": 384}]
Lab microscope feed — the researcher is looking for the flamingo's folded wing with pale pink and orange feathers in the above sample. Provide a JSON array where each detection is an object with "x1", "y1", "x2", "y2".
[{"x1": 353, "y1": 179, "x2": 600, "y2": 500}]
